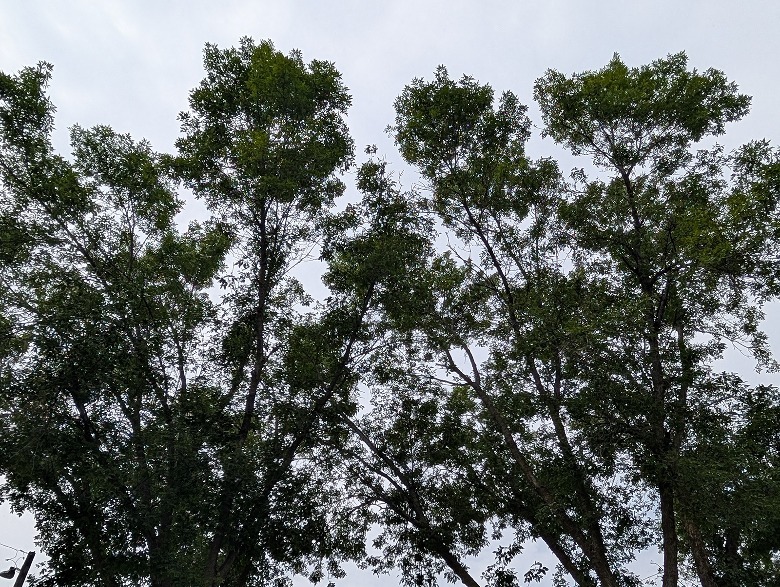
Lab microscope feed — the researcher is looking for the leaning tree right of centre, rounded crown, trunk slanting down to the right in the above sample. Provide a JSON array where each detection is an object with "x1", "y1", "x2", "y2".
[{"x1": 386, "y1": 63, "x2": 641, "y2": 585}]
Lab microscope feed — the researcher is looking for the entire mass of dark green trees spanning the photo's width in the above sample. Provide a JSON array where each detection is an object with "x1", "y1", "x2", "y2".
[{"x1": 0, "y1": 39, "x2": 780, "y2": 587}]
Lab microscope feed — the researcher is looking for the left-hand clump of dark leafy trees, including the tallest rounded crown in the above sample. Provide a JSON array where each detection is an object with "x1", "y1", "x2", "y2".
[{"x1": 0, "y1": 39, "x2": 362, "y2": 586}]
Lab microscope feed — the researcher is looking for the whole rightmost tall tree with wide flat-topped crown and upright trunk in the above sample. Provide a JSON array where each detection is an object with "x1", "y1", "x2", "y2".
[{"x1": 535, "y1": 54, "x2": 780, "y2": 587}]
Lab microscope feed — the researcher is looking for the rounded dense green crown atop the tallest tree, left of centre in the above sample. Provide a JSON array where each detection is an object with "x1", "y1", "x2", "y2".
[{"x1": 177, "y1": 38, "x2": 353, "y2": 212}]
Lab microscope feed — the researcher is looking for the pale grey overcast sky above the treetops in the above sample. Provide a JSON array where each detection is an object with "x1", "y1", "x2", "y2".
[{"x1": 0, "y1": 0, "x2": 780, "y2": 585}]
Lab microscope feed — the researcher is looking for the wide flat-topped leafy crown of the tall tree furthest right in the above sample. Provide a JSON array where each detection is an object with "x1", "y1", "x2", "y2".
[{"x1": 534, "y1": 53, "x2": 750, "y2": 175}]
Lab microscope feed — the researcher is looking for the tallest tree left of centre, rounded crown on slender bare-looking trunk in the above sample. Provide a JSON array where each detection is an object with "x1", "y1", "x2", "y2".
[{"x1": 176, "y1": 39, "x2": 352, "y2": 580}]
